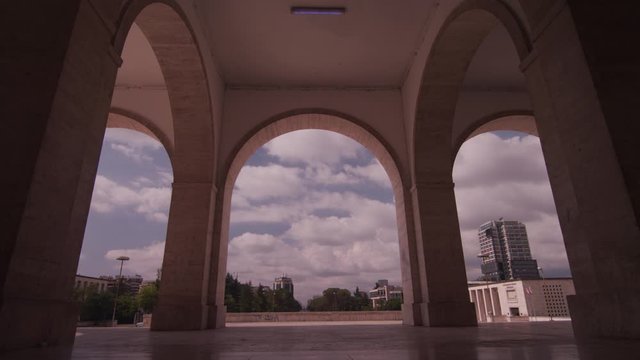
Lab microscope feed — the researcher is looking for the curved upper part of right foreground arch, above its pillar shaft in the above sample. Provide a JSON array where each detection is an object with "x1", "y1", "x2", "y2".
[{"x1": 413, "y1": 0, "x2": 532, "y2": 181}]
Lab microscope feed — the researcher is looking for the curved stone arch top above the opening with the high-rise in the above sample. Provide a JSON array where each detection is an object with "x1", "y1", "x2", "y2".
[{"x1": 453, "y1": 110, "x2": 538, "y2": 158}]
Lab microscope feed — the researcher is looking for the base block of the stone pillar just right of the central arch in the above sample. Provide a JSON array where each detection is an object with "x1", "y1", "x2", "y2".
[{"x1": 420, "y1": 301, "x2": 478, "y2": 327}]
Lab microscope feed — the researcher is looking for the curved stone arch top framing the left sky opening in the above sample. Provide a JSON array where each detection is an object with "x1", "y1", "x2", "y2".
[{"x1": 107, "y1": 107, "x2": 173, "y2": 160}]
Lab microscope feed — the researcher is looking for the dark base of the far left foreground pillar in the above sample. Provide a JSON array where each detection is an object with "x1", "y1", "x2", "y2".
[{"x1": 0, "y1": 298, "x2": 80, "y2": 352}]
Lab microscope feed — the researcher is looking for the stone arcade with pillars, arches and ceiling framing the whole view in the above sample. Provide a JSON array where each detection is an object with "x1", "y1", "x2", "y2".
[{"x1": 0, "y1": 0, "x2": 640, "y2": 350}]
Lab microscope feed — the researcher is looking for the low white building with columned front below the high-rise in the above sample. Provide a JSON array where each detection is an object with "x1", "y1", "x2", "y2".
[{"x1": 469, "y1": 278, "x2": 576, "y2": 322}]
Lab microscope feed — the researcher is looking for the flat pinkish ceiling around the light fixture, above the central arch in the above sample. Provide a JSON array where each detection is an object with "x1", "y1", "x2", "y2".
[{"x1": 198, "y1": 0, "x2": 435, "y2": 87}]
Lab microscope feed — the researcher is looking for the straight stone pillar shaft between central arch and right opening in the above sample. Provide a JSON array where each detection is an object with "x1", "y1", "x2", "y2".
[{"x1": 412, "y1": 180, "x2": 477, "y2": 326}]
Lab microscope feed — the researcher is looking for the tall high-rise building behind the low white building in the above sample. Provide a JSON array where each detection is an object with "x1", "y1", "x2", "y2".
[{"x1": 478, "y1": 218, "x2": 540, "y2": 281}]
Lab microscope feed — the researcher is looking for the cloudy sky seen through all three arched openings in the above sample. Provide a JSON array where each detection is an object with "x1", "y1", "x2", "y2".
[{"x1": 78, "y1": 129, "x2": 569, "y2": 304}]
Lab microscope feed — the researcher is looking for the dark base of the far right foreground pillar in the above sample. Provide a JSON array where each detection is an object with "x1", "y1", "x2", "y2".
[{"x1": 567, "y1": 289, "x2": 640, "y2": 341}]
